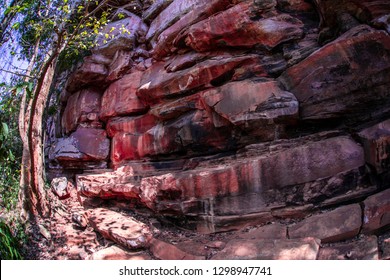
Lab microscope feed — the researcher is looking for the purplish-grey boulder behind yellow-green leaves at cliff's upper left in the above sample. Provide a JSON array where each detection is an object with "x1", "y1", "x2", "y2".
[{"x1": 92, "y1": 14, "x2": 148, "y2": 57}]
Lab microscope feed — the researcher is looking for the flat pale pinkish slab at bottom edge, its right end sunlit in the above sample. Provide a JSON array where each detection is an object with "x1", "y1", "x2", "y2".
[{"x1": 211, "y1": 238, "x2": 321, "y2": 260}]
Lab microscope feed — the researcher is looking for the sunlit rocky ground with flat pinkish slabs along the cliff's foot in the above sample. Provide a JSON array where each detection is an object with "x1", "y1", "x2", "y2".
[{"x1": 25, "y1": 186, "x2": 390, "y2": 260}]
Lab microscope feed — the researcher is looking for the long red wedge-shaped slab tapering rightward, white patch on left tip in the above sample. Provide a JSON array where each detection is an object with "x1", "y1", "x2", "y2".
[{"x1": 137, "y1": 55, "x2": 257, "y2": 103}]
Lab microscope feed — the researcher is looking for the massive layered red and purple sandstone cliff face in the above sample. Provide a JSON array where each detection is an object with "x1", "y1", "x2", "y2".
[{"x1": 49, "y1": 0, "x2": 390, "y2": 258}]
